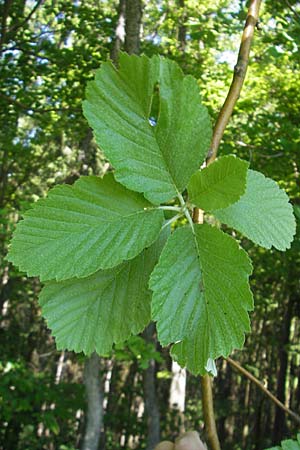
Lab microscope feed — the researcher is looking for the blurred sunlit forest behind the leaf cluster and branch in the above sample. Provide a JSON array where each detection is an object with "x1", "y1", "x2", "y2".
[{"x1": 0, "y1": 0, "x2": 300, "y2": 450}]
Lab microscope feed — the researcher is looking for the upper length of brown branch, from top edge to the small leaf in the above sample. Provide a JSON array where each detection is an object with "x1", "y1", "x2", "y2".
[{"x1": 208, "y1": 0, "x2": 261, "y2": 163}]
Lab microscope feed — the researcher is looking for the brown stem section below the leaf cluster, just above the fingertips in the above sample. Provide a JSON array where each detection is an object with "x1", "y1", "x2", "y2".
[{"x1": 201, "y1": 375, "x2": 221, "y2": 450}]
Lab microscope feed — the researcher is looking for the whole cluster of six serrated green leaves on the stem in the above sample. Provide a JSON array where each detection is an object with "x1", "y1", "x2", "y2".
[{"x1": 8, "y1": 54, "x2": 295, "y2": 374}]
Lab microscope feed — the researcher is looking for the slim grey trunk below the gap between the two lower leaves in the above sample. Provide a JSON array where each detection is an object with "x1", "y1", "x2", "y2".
[{"x1": 143, "y1": 323, "x2": 160, "y2": 450}]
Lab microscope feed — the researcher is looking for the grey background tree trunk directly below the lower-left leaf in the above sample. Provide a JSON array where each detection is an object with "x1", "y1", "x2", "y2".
[{"x1": 82, "y1": 353, "x2": 103, "y2": 450}]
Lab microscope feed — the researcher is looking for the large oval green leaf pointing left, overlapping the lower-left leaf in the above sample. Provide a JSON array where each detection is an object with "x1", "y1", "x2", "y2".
[{"x1": 8, "y1": 174, "x2": 163, "y2": 281}]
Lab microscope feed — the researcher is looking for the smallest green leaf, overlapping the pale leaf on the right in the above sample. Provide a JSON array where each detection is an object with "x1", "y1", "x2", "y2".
[{"x1": 188, "y1": 155, "x2": 249, "y2": 211}]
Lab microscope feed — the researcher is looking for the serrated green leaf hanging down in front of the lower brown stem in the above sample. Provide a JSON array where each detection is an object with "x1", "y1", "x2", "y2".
[{"x1": 150, "y1": 224, "x2": 253, "y2": 374}]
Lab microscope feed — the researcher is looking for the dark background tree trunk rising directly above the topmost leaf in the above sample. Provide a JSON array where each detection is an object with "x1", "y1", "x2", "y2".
[{"x1": 125, "y1": 0, "x2": 142, "y2": 55}]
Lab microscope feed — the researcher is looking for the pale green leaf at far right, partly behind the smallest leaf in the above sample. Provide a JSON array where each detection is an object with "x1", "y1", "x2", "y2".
[{"x1": 213, "y1": 170, "x2": 296, "y2": 251}]
